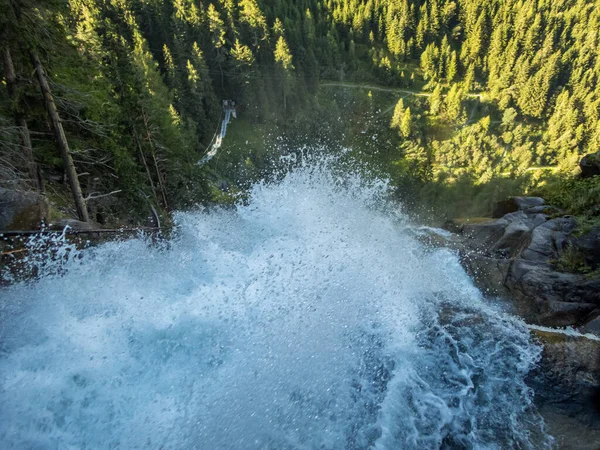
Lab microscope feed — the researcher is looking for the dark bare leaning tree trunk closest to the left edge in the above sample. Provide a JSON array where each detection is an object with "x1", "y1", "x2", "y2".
[{"x1": 4, "y1": 46, "x2": 44, "y2": 192}]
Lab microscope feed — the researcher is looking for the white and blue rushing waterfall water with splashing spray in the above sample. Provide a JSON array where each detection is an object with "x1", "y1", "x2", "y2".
[{"x1": 0, "y1": 157, "x2": 551, "y2": 450}]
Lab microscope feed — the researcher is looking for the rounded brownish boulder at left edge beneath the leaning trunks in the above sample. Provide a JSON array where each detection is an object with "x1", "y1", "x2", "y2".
[{"x1": 0, "y1": 188, "x2": 49, "y2": 231}]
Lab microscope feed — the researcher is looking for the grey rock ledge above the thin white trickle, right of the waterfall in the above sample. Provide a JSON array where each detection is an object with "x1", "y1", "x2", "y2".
[{"x1": 445, "y1": 197, "x2": 600, "y2": 334}]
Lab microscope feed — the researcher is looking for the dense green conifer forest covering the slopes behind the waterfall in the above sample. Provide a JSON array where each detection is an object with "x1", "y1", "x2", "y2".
[{"x1": 0, "y1": 0, "x2": 600, "y2": 225}]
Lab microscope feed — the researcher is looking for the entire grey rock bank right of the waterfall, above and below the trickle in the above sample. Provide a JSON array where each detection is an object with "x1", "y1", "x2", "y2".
[{"x1": 445, "y1": 197, "x2": 600, "y2": 442}]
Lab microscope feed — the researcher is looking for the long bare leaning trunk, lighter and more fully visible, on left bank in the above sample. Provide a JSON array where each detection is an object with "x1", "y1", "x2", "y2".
[{"x1": 31, "y1": 51, "x2": 90, "y2": 222}]
